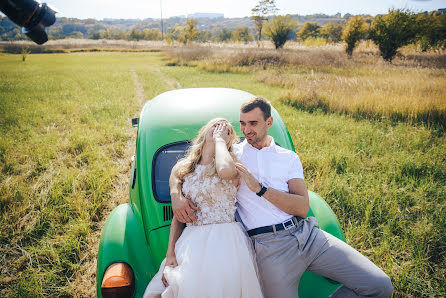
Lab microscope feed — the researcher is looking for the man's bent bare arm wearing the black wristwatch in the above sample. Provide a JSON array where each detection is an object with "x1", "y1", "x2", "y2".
[{"x1": 236, "y1": 163, "x2": 310, "y2": 218}]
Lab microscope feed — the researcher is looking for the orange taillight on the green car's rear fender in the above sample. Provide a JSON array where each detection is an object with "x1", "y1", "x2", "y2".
[{"x1": 101, "y1": 263, "x2": 135, "y2": 298}]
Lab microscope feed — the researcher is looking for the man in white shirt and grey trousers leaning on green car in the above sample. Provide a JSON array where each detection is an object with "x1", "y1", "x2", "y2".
[{"x1": 170, "y1": 97, "x2": 393, "y2": 298}]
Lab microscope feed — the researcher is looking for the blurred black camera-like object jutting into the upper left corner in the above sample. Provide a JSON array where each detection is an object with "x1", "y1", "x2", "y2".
[{"x1": 0, "y1": 0, "x2": 58, "y2": 44}]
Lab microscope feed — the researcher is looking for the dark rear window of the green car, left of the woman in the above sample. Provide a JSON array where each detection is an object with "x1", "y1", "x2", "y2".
[{"x1": 152, "y1": 141, "x2": 190, "y2": 203}]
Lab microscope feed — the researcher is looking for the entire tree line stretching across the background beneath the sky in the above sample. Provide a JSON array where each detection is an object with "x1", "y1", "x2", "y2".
[{"x1": 0, "y1": 4, "x2": 446, "y2": 62}]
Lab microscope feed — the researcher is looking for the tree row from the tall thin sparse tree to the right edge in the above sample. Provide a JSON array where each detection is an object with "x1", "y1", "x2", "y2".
[{"x1": 252, "y1": 0, "x2": 446, "y2": 62}]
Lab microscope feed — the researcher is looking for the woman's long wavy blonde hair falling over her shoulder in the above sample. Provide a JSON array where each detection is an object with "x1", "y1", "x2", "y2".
[{"x1": 177, "y1": 118, "x2": 239, "y2": 182}]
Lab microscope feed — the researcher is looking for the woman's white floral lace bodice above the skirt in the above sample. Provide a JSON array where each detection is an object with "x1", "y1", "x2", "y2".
[{"x1": 182, "y1": 165, "x2": 237, "y2": 225}]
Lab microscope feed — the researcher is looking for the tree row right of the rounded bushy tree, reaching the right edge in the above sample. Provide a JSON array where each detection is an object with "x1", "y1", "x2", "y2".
[{"x1": 298, "y1": 9, "x2": 446, "y2": 62}]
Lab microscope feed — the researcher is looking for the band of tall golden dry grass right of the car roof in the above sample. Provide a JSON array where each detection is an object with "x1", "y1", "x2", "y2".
[{"x1": 257, "y1": 65, "x2": 446, "y2": 129}]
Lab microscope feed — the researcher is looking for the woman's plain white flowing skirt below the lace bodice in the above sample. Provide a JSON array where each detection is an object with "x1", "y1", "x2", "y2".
[{"x1": 144, "y1": 222, "x2": 263, "y2": 298}]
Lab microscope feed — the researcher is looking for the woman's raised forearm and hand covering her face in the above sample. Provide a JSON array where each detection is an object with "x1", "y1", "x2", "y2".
[{"x1": 213, "y1": 123, "x2": 238, "y2": 179}]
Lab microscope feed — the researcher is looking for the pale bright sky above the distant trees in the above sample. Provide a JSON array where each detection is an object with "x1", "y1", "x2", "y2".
[{"x1": 7, "y1": 0, "x2": 446, "y2": 20}]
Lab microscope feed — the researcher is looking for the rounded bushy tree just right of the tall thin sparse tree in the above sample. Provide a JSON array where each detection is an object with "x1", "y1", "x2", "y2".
[{"x1": 265, "y1": 16, "x2": 297, "y2": 49}]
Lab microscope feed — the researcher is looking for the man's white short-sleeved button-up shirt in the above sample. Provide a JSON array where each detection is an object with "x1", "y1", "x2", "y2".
[{"x1": 234, "y1": 136, "x2": 304, "y2": 230}]
